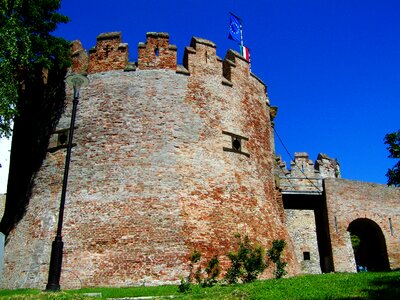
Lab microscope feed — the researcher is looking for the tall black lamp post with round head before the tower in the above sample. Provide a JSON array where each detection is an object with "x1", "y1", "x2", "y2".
[{"x1": 46, "y1": 74, "x2": 89, "y2": 291}]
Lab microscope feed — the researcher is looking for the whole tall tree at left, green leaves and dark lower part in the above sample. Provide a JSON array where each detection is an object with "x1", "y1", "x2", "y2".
[{"x1": 0, "y1": 0, "x2": 70, "y2": 235}]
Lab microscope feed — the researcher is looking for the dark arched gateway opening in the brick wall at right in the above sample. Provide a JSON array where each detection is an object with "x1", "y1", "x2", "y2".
[{"x1": 347, "y1": 218, "x2": 390, "y2": 271}]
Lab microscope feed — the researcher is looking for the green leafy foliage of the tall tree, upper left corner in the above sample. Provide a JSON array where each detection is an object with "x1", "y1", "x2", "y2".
[{"x1": 0, "y1": 0, "x2": 69, "y2": 138}]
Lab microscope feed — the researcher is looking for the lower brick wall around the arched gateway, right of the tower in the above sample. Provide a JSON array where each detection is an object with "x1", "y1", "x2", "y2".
[{"x1": 325, "y1": 179, "x2": 400, "y2": 272}]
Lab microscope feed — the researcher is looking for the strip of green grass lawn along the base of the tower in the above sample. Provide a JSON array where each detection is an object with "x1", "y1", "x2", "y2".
[{"x1": 0, "y1": 271, "x2": 400, "y2": 300}]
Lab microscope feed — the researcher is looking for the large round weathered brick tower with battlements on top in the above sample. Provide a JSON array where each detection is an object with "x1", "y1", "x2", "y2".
[{"x1": 3, "y1": 33, "x2": 298, "y2": 288}]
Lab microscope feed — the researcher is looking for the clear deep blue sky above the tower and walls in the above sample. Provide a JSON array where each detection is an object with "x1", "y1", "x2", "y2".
[{"x1": 55, "y1": 0, "x2": 400, "y2": 183}]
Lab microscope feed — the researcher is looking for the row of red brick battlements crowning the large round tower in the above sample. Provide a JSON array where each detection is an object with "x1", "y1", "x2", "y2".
[{"x1": 71, "y1": 32, "x2": 265, "y2": 90}]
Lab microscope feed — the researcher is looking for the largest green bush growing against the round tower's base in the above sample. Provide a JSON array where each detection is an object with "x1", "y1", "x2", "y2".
[{"x1": 225, "y1": 235, "x2": 267, "y2": 283}]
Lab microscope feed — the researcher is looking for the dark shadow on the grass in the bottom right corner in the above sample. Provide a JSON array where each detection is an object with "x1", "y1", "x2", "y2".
[{"x1": 364, "y1": 273, "x2": 400, "y2": 300}]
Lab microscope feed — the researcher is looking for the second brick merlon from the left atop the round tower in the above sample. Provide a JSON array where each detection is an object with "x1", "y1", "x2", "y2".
[{"x1": 88, "y1": 32, "x2": 128, "y2": 73}]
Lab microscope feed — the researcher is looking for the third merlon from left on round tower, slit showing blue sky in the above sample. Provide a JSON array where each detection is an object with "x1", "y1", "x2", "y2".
[{"x1": 138, "y1": 32, "x2": 177, "y2": 70}]
